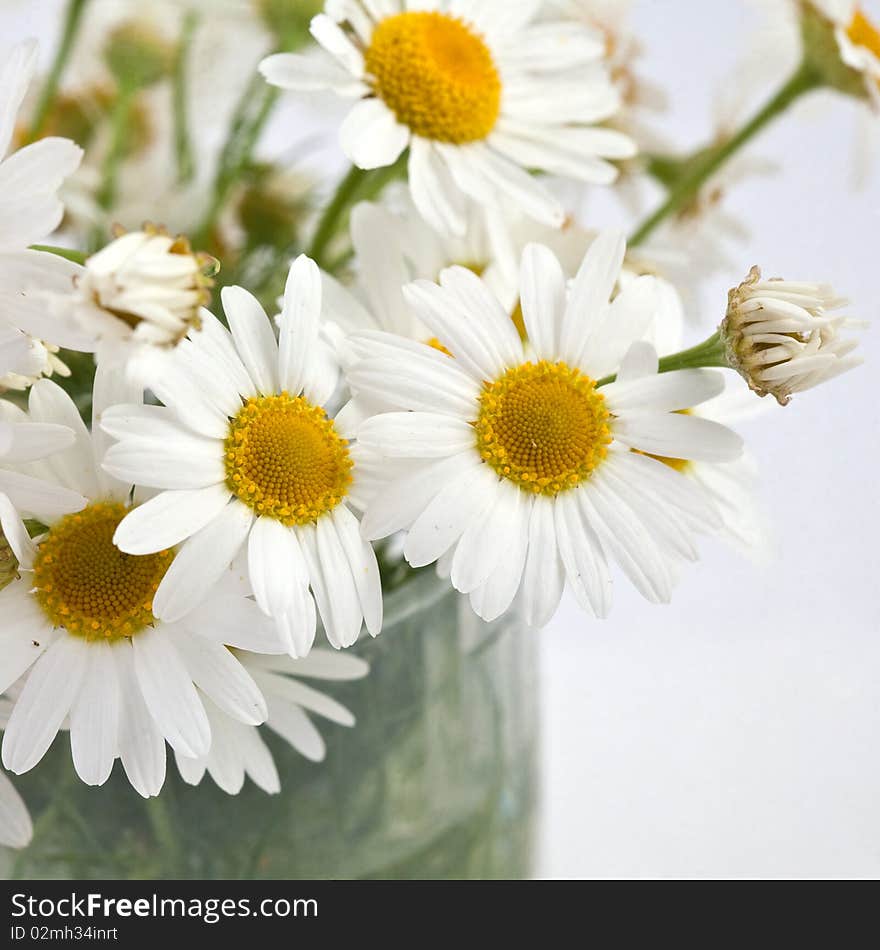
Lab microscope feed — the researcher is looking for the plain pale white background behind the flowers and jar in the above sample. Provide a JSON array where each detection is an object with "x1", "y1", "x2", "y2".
[{"x1": 6, "y1": 0, "x2": 880, "y2": 878}]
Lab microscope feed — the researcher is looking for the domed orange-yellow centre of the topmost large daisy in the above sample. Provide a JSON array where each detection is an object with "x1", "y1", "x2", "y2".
[{"x1": 364, "y1": 11, "x2": 501, "y2": 145}]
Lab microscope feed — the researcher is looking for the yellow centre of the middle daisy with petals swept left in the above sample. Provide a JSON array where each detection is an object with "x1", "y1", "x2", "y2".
[{"x1": 225, "y1": 393, "x2": 352, "y2": 525}]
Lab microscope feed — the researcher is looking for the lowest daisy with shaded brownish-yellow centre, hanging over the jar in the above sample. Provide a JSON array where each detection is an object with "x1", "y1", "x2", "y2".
[{"x1": 0, "y1": 370, "x2": 275, "y2": 796}]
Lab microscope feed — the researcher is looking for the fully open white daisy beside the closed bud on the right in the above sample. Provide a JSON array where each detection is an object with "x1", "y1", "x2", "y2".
[{"x1": 348, "y1": 233, "x2": 741, "y2": 625}]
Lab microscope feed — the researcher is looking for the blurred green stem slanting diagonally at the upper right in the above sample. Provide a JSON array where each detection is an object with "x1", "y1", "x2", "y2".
[{"x1": 629, "y1": 61, "x2": 822, "y2": 247}]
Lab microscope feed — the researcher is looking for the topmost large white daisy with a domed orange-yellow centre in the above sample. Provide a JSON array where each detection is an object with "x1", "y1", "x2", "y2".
[{"x1": 260, "y1": 0, "x2": 635, "y2": 234}]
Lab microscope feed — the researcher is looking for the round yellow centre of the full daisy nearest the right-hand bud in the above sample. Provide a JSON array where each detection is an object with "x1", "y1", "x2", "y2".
[{"x1": 474, "y1": 361, "x2": 611, "y2": 495}]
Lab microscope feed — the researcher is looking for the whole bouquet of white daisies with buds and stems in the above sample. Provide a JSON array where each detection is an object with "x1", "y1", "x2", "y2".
[{"x1": 0, "y1": 0, "x2": 868, "y2": 846}]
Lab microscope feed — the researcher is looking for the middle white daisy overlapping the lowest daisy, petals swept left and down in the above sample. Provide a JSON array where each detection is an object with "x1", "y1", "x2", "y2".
[{"x1": 103, "y1": 257, "x2": 382, "y2": 656}]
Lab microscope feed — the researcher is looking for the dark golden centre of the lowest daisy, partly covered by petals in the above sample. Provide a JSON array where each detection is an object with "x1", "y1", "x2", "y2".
[{"x1": 34, "y1": 502, "x2": 174, "y2": 642}]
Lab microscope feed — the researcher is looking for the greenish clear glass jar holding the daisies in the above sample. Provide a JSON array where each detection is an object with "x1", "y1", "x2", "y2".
[{"x1": 2, "y1": 574, "x2": 537, "y2": 879}]
